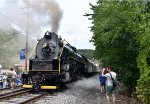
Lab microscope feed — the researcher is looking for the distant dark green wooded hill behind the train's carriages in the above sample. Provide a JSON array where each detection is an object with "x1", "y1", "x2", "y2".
[{"x1": 78, "y1": 49, "x2": 94, "y2": 59}]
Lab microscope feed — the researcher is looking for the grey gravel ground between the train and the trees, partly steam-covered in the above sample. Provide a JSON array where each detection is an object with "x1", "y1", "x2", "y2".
[{"x1": 34, "y1": 75, "x2": 140, "y2": 104}]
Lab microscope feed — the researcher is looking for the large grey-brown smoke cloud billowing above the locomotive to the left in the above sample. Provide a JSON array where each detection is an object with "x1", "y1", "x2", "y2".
[{"x1": 0, "y1": 0, "x2": 62, "y2": 35}]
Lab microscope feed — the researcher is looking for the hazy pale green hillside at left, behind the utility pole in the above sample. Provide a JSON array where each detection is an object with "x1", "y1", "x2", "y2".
[{"x1": 0, "y1": 32, "x2": 19, "y2": 68}]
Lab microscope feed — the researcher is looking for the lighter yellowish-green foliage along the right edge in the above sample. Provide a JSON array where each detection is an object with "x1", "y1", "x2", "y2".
[{"x1": 136, "y1": 1, "x2": 150, "y2": 104}]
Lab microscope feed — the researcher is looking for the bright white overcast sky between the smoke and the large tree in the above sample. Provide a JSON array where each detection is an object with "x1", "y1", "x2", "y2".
[{"x1": 0, "y1": 0, "x2": 97, "y2": 49}]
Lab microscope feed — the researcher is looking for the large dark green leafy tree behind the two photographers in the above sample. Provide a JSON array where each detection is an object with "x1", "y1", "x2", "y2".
[{"x1": 88, "y1": 0, "x2": 139, "y2": 91}]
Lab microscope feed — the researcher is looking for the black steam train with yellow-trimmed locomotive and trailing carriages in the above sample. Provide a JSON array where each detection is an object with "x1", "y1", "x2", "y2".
[{"x1": 22, "y1": 31, "x2": 97, "y2": 89}]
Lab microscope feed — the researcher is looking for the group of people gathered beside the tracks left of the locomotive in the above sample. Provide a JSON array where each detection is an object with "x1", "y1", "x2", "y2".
[{"x1": 0, "y1": 68, "x2": 22, "y2": 89}]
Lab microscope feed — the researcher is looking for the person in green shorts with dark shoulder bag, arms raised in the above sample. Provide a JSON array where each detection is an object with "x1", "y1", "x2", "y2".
[{"x1": 102, "y1": 68, "x2": 116, "y2": 104}]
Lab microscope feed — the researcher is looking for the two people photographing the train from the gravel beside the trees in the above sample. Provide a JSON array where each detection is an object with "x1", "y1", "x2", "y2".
[{"x1": 99, "y1": 67, "x2": 116, "y2": 104}]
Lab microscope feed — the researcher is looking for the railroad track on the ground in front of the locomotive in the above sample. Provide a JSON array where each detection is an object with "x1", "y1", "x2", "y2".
[{"x1": 0, "y1": 89, "x2": 53, "y2": 104}]
